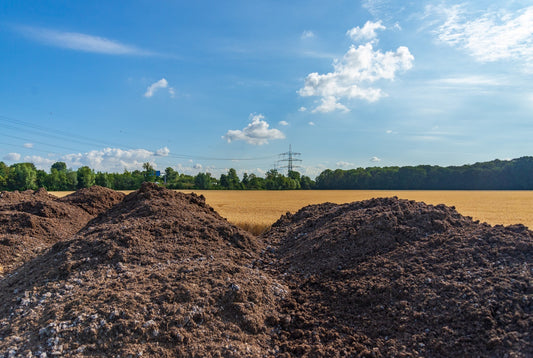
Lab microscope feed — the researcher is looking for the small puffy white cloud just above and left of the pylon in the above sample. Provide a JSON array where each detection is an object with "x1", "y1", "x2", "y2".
[{"x1": 222, "y1": 114, "x2": 285, "y2": 145}]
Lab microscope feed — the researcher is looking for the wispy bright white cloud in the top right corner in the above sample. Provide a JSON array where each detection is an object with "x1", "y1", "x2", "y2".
[{"x1": 426, "y1": 5, "x2": 533, "y2": 69}]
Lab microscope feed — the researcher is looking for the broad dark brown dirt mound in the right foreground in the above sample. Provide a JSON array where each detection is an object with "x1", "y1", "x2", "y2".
[{"x1": 264, "y1": 198, "x2": 533, "y2": 357}]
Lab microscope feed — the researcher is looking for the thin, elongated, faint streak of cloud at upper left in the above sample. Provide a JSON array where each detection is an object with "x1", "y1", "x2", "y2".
[{"x1": 16, "y1": 26, "x2": 153, "y2": 56}]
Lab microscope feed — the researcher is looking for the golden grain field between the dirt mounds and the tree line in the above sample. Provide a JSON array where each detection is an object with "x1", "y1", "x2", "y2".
[{"x1": 51, "y1": 190, "x2": 533, "y2": 234}]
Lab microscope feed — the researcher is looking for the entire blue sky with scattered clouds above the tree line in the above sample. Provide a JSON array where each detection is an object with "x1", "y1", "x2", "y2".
[{"x1": 0, "y1": 0, "x2": 533, "y2": 178}]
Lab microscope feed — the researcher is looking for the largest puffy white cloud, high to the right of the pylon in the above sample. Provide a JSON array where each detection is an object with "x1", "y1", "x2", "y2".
[{"x1": 298, "y1": 43, "x2": 414, "y2": 112}]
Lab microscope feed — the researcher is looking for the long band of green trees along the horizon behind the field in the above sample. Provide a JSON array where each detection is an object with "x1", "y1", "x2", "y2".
[{"x1": 0, "y1": 157, "x2": 533, "y2": 191}]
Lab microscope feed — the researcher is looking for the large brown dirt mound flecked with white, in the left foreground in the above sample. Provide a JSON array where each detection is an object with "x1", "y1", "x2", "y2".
[{"x1": 0, "y1": 184, "x2": 287, "y2": 357}]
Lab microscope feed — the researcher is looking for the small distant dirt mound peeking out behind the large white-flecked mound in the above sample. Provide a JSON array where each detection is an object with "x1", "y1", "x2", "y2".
[{"x1": 58, "y1": 185, "x2": 125, "y2": 216}]
